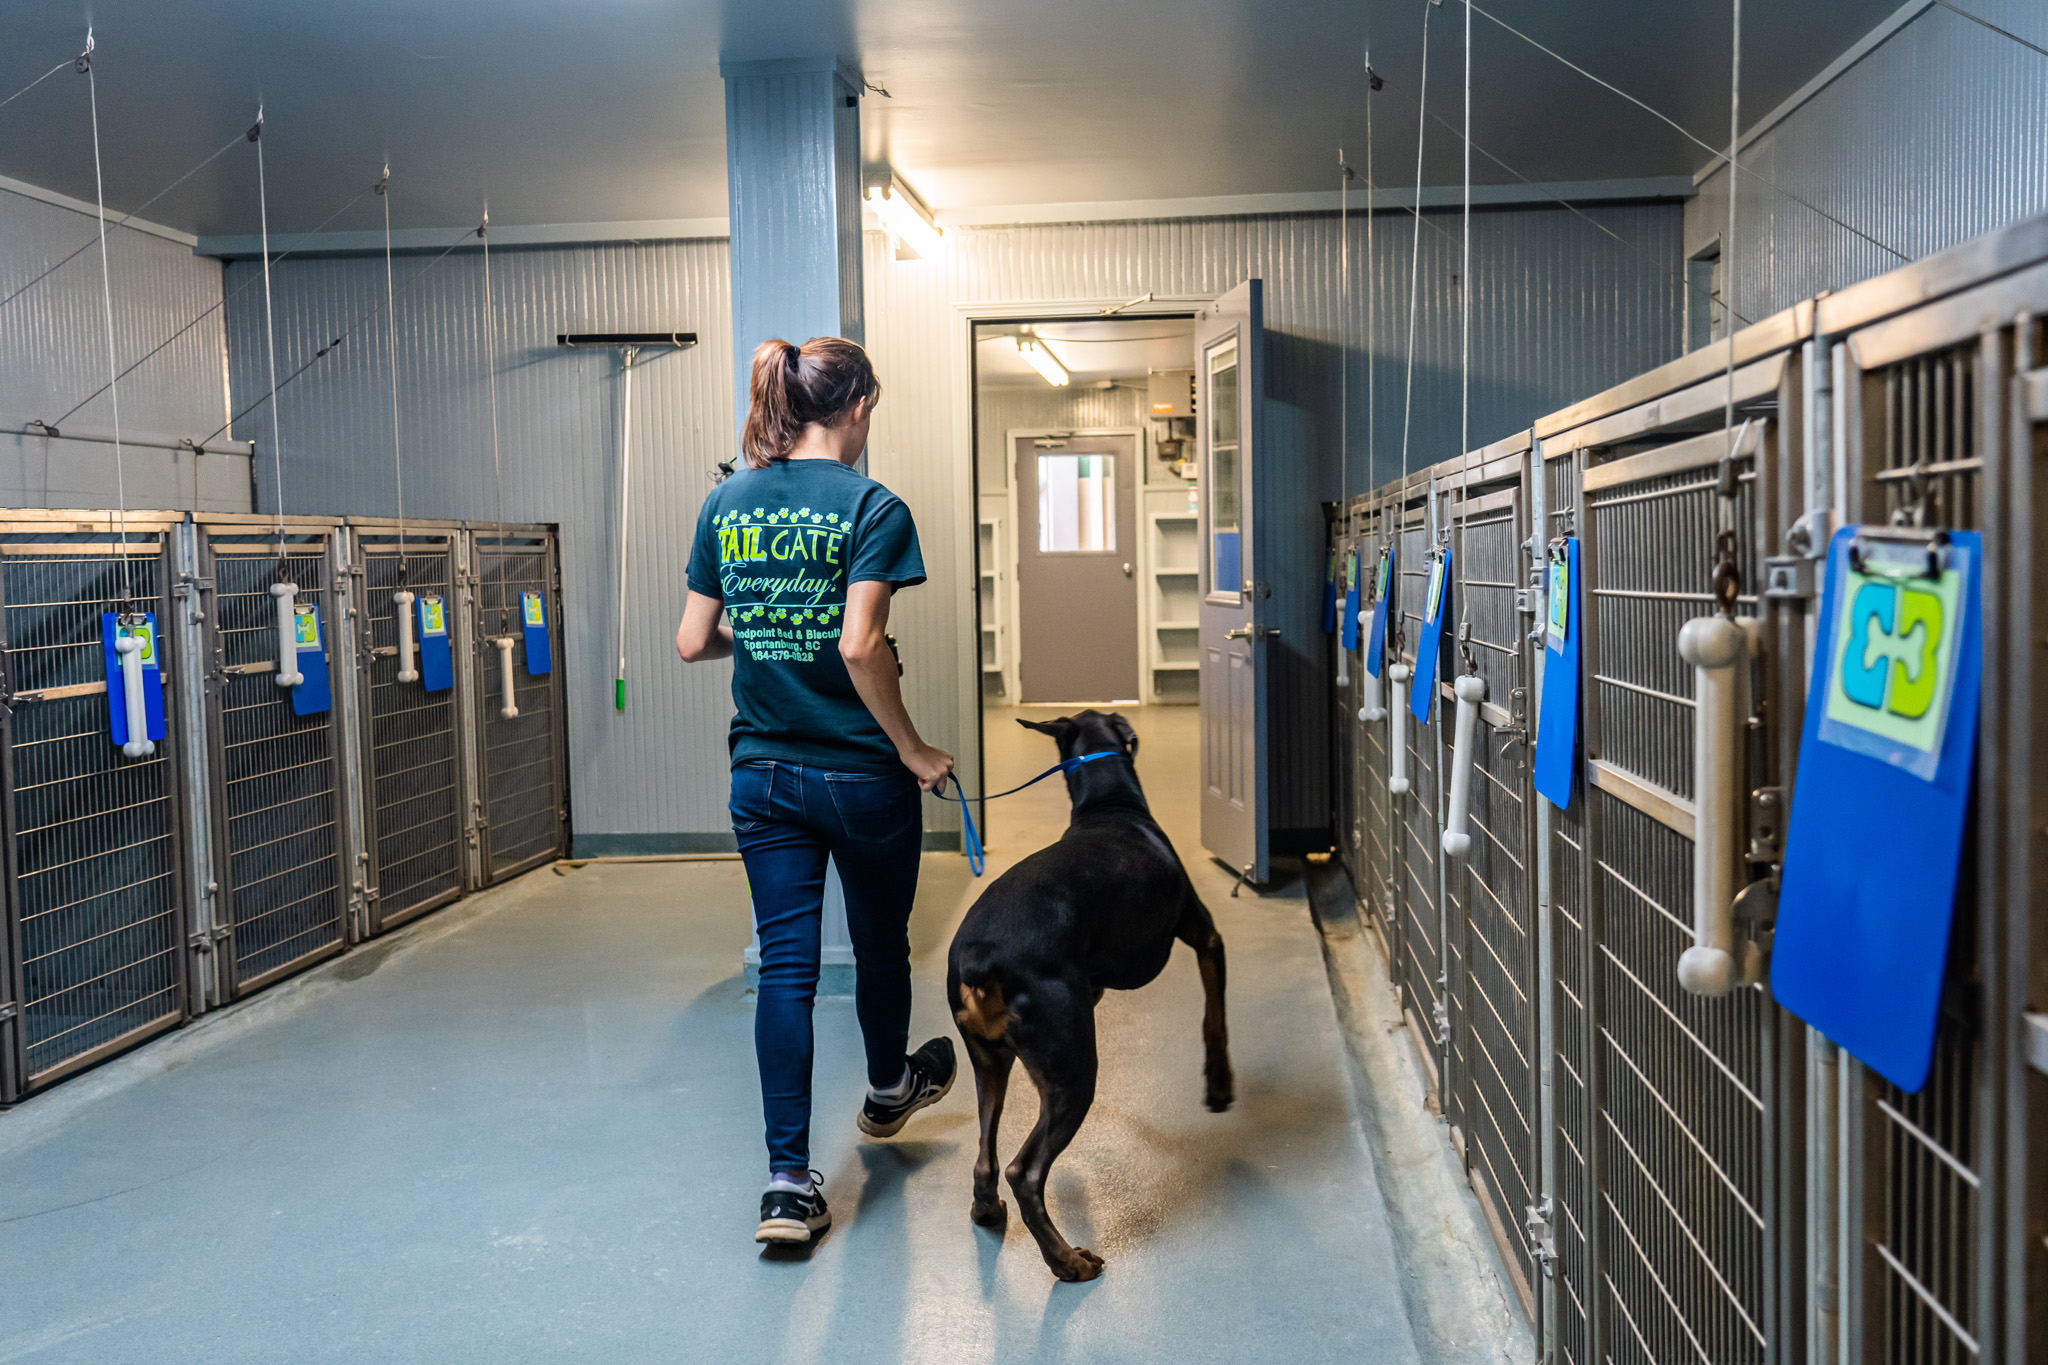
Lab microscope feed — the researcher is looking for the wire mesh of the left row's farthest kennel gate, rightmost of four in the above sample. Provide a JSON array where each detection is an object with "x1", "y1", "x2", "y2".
[{"x1": 475, "y1": 530, "x2": 569, "y2": 882}]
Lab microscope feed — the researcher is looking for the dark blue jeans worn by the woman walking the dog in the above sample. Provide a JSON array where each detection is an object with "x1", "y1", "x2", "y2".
[{"x1": 733, "y1": 759, "x2": 924, "y2": 1173}]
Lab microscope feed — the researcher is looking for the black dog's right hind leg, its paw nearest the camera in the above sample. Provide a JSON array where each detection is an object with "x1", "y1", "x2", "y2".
[{"x1": 1006, "y1": 982, "x2": 1102, "y2": 1279}]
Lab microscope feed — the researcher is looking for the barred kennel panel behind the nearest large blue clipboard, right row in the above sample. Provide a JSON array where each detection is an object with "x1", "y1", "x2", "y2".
[{"x1": 1847, "y1": 338, "x2": 1982, "y2": 1365}]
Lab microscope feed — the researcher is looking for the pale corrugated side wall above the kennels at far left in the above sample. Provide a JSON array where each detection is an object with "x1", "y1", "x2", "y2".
[{"x1": 0, "y1": 190, "x2": 248, "y2": 510}]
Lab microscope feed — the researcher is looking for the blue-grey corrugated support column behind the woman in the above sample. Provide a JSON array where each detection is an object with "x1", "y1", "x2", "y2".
[{"x1": 719, "y1": 57, "x2": 866, "y2": 995}]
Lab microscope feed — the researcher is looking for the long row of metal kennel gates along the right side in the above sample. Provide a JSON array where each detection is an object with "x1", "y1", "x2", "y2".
[{"x1": 1333, "y1": 208, "x2": 2048, "y2": 1365}]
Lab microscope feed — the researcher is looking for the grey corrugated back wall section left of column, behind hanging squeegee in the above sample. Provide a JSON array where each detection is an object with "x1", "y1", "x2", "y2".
[{"x1": 227, "y1": 233, "x2": 733, "y2": 847}]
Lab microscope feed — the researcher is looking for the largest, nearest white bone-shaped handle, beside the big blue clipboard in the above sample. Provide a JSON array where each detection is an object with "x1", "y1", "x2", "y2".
[{"x1": 1677, "y1": 616, "x2": 1757, "y2": 995}]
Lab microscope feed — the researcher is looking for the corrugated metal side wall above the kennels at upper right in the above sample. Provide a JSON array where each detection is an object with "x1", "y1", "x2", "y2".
[{"x1": 1686, "y1": 0, "x2": 2048, "y2": 319}]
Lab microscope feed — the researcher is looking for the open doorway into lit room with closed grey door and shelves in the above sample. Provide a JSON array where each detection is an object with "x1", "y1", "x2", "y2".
[{"x1": 973, "y1": 315, "x2": 1200, "y2": 708}]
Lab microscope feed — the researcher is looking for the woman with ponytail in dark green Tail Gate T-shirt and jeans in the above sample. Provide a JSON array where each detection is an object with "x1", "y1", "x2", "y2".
[{"x1": 676, "y1": 336, "x2": 954, "y2": 1242}]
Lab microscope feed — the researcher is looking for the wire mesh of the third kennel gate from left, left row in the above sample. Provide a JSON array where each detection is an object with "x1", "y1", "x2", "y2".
[{"x1": 352, "y1": 526, "x2": 465, "y2": 933}]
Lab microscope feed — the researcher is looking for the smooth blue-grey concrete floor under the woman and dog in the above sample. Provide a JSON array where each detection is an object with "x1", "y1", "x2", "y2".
[{"x1": 0, "y1": 708, "x2": 1474, "y2": 1365}]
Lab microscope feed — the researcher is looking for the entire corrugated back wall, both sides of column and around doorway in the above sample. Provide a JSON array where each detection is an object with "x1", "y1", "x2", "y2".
[{"x1": 216, "y1": 205, "x2": 1681, "y2": 847}]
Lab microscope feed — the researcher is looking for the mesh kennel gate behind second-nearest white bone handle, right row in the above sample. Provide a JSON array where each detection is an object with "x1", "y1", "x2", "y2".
[{"x1": 1442, "y1": 489, "x2": 1540, "y2": 1318}]
